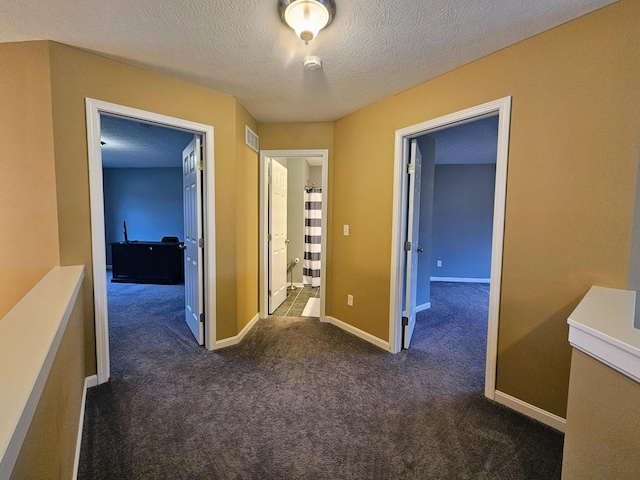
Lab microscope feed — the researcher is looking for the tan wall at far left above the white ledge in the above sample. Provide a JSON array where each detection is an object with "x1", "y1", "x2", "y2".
[{"x1": 0, "y1": 42, "x2": 60, "y2": 319}]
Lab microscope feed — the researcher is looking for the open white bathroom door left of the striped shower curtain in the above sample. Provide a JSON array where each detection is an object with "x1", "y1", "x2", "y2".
[{"x1": 269, "y1": 160, "x2": 287, "y2": 315}]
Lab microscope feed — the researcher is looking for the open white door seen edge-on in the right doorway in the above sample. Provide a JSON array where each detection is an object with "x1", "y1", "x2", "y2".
[{"x1": 402, "y1": 139, "x2": 422, "y2": 348}]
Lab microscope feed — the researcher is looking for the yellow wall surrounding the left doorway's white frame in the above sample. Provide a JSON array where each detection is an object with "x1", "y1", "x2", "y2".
[{"x1": 49, "y1": 43, "x2": 257, "y2": 374}]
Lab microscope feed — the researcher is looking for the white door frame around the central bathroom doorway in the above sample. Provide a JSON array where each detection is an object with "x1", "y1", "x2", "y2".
[{"x1": 259, "y1": 149, "x2": 329, "y2": 322}]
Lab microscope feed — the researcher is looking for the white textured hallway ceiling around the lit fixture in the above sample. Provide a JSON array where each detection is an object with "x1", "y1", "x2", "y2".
[{"x1": 0, "y1": 0, "x2": 614, "y2": 123}]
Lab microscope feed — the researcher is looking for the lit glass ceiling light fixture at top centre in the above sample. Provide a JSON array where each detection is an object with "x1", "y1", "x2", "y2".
[{"x1": 278, "y1": 0, "x2": 336, "y2": 45}]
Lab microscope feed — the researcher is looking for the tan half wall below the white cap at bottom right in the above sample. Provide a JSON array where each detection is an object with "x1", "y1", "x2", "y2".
[{"x1": 562, "y1": 350, "x2": 640, "y2": 480}]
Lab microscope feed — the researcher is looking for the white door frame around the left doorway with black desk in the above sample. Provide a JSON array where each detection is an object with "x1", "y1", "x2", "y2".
[{"x1": 85, "y1": 98, "x2": 216, "y2": 384}]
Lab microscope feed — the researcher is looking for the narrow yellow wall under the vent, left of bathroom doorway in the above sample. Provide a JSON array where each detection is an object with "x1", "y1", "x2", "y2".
[{"x1": 236, "y1": 103, "x2": 259, "y2": 332}]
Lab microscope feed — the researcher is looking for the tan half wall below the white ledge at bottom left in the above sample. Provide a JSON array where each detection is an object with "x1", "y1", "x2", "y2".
[{"x1": 11, "y1": 292, "x2": 85, "y2": 480}]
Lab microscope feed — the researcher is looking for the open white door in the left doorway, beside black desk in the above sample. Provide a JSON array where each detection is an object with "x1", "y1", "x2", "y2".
[{"x1": 182, "y1": 135, "x2": 204, "y2": 345}]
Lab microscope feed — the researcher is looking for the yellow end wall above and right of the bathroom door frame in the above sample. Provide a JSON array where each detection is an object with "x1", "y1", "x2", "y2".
[{"x1": 258, "y1": 122, "x2": 334, "y2": 306}]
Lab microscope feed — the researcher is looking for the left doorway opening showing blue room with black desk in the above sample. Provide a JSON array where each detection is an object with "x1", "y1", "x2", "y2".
[{"x1": 100, "y1": 115, "x2": 195, "y2": 372}]
